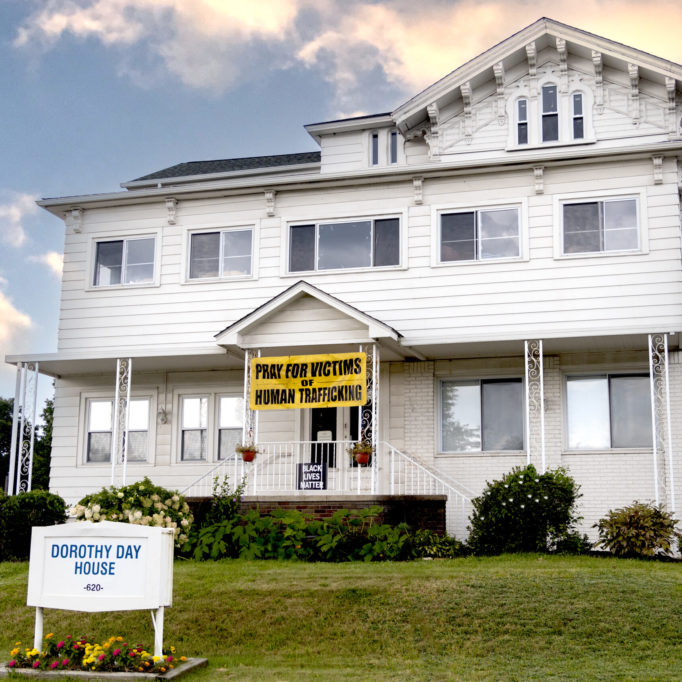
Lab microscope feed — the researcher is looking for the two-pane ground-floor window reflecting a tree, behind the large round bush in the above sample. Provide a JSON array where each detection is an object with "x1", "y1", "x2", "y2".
[{"x1": 441, "y1": 379, "x2": 524, "y2": 452}]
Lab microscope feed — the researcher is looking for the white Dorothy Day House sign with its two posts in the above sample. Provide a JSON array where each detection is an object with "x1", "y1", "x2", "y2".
[{"x1": 26, "y1": 521, "x2": 174, "y2": 656}]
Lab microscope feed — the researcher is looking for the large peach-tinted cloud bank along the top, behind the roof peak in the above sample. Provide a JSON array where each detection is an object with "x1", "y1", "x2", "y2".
[{"x1": 15, "y1": 0, "x2": 682, "y2": 112}]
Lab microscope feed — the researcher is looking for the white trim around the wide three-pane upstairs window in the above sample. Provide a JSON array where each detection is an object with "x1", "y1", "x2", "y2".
[{"x1": 280, "y1": 208, "x2": 408, "y2": 279}]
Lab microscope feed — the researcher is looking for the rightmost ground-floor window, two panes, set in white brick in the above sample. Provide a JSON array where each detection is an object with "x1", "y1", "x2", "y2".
[{"x1": 566, "y1": 374, "x2": 652, "y2": 450}]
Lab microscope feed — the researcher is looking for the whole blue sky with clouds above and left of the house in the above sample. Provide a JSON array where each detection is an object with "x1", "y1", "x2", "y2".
[{"x1": 0, "y1": 0, "x2": 682, "y2": 404}]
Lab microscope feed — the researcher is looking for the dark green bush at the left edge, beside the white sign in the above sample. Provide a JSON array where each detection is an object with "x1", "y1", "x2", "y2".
[{"x1": 0, "y1": 490, "x2": 66, "y2": 561}]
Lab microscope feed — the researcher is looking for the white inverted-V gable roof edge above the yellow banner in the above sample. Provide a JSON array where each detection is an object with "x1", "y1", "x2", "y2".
[{"x1": 215, "y1": 280, "x2": 402, "y2": 345}]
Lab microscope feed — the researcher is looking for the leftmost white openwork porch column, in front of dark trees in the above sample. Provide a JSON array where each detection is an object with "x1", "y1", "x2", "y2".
[{"x1": 7, "y1": 362, "x2": 38, "y2": 495}]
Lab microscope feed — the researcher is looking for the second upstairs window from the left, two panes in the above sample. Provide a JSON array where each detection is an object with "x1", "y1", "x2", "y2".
[{"x1": 189, "y1": 229, "x2": 253, "y2": 279}]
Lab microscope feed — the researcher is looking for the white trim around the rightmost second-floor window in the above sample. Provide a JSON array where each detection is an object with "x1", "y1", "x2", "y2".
[{"x1": 552, "y1": 187, "x2": 649, "y2": 260}]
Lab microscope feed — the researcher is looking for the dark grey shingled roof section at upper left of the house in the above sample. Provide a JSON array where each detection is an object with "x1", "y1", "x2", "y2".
[{"x1": 123, "y1": 152, "x2": 320, "y2": 187}]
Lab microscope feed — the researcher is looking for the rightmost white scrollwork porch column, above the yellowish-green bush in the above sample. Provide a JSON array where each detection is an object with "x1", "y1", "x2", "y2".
[{"x1": 649, "y1": 334, "x2": 676, "y2": 512}]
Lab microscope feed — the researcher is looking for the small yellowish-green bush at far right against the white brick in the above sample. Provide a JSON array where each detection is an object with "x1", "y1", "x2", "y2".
[{"x1": 594, "y1": 501, "x2": 682, "y2": 557}]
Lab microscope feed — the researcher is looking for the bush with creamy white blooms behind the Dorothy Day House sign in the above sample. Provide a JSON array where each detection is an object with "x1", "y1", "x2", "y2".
[{"x1": 71, "y1": 477, "x2": 194, "y2": 547}]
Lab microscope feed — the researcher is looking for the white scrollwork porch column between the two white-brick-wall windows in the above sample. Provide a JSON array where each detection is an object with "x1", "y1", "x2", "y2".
[{"x1": 524, "y1": 339, "x2": 547, "y2": 474}]
